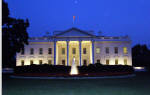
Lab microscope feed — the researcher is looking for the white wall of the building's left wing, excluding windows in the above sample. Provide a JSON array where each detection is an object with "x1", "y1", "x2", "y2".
[{"x1": 16, "y1": 42, "x2": 54, "y2": 66}]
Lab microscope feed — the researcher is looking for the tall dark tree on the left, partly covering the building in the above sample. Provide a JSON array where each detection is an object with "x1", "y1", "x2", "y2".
[{"x1": 2, "y1": 0, "x2": 29, "y2": 67}]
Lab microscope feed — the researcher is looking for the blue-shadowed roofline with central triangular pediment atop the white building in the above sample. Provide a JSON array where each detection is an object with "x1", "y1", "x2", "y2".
[{"x1": 29, "y1": 27, "x2": 131, "y2": 42}]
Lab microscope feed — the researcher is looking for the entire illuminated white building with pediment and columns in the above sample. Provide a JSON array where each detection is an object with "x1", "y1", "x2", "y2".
[{"x1": 16, "y1": 28, "x2": 132, "y2": 66}]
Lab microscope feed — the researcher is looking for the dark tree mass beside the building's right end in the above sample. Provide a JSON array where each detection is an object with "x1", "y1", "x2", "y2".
[{"x1": 132, "y1": 44, "x2": 150, "y2": 68}]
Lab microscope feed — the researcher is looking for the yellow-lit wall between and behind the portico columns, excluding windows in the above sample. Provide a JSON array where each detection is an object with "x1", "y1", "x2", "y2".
[{"x1": 56, "y1": 41, "x2": 92, "y2": 66}]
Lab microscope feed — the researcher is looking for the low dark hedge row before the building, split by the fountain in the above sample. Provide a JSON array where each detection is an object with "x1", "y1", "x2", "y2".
[{"x1": 14, "y1": 63, "x2": 134, "y2": 74}]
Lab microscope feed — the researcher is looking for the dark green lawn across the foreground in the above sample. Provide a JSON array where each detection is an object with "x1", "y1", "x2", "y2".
[{"x1": 2, "y1": 73, "x2": 150, "y2": 95}]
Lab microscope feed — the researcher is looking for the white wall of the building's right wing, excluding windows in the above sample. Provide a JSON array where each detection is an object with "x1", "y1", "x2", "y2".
[{"x1": 94, "y1": 41, "x2": 132, "y2": 65}]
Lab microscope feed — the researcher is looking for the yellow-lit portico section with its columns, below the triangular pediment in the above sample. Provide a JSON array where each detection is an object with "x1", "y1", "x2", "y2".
[{"x1": 54, "y1": 41, "x2": 94, "y2": 66}]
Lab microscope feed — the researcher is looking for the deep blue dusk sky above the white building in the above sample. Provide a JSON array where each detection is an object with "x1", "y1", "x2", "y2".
[{"x1": 5, "y1": 0, "x2": 150, "y2": 45}]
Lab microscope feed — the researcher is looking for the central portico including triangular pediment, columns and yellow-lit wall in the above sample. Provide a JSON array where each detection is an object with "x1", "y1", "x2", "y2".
[{"x1": 53, "y1": 28, "x2": 96, "y2": 66}]
